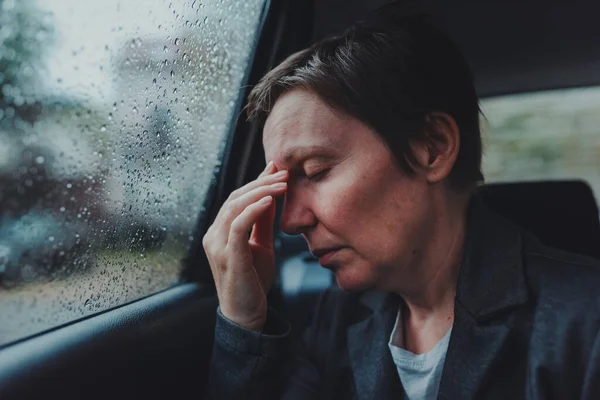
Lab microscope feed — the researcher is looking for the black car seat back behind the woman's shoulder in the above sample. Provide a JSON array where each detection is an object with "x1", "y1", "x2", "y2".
[{"x1": 478, "y1": 180, "x2": 600, "y2": 258}]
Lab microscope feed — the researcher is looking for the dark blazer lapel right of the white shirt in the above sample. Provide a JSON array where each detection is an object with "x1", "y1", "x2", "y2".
[{"x1": 438, "y1": 204, "x2": 528, "y2": 399}]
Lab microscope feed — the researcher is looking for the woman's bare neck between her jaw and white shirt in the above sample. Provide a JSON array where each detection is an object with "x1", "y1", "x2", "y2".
[{"x1": 396, "y1": 190, "x2": 468, "y2": 324}]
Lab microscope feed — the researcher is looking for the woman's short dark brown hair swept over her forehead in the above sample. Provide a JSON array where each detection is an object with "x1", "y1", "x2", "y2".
[{"x1": 247, "y1": 10, "x2": 483, "y2": 188}]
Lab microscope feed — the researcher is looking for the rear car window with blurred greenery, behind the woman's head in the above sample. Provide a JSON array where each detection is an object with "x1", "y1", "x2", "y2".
[{"x1": 481, "y1": 87, "x2": 600, "y2": 199}]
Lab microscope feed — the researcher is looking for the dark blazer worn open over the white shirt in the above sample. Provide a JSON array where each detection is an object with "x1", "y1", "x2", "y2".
[{"x1": 208, "y1": 202, "x2": 600, "y2": 400}]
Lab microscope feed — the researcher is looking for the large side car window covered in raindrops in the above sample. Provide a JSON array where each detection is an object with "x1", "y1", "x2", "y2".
[{"x1": 0, "y1": 0, "x2": 264, "y2": 345}]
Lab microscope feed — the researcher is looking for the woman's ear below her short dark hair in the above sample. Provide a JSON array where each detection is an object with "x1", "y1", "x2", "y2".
[{"x1": 411, "y1": 112, "x2": 460, "y2": 183}]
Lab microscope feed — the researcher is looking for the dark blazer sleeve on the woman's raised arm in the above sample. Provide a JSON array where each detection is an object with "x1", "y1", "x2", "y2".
[{"x1": 207, "y1": 299, "x2": 322, "y2": 400}]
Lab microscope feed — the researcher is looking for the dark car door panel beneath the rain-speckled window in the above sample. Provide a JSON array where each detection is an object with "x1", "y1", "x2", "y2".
[{"x1": 0, "y1": 283, "x2": 217, "y2": 399}]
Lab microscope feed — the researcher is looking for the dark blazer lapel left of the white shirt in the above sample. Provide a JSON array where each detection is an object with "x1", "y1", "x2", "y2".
[{"x1": 348, "y1": 293, "x2": 403, "y2": 399}]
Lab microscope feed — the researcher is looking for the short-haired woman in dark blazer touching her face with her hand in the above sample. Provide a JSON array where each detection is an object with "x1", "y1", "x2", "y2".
[{"x1": 203, "y1": 9, "x2": 600, "y2": 399}]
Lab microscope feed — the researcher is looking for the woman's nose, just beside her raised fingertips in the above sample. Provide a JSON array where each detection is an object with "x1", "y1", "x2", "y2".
[{"x1": 281, "y1": 185, "x2": 317, "y2": 235}]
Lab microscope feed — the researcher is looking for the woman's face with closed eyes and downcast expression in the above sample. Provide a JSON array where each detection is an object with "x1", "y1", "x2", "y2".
[{"x1": 263, "y1": 89, "x2": 434, "y2": 290}]
